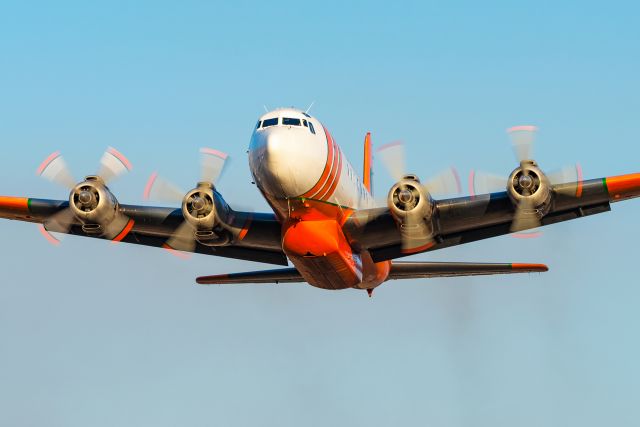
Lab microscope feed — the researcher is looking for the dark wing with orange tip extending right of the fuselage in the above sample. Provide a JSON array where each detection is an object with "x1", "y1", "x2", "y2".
[{"x1": 345, "y1": 174, "x2": 640, "y2": 262}]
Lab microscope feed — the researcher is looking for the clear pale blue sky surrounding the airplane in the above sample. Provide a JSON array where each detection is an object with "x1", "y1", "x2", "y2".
[{"x1": 0, "y1": 1, "x2": 640, "y2": 427}]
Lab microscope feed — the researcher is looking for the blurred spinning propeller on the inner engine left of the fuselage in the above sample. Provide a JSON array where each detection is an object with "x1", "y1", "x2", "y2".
[{"x1": 143, "y1": 148, "x2": 229, "y2": 253}]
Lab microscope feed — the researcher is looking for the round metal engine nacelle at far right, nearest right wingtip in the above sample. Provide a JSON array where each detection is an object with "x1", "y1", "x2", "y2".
[{"x1": 507, "y1": 160, "x2": 552, "y2": 218}]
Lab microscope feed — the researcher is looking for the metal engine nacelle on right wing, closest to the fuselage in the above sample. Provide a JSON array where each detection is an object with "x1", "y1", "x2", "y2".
[{"x1": 387, "y1": 175, "x2": 434, "y2": 239}]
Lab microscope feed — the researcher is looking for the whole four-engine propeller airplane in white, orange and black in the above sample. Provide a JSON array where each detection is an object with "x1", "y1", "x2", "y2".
[{"x1": 0, "y1": 109, "x2": 640, "y2": 295}]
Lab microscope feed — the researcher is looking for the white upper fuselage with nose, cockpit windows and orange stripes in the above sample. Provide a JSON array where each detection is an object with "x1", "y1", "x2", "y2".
[{"x1": 249, "y1": 109, "x2": 373, "y2": 214}]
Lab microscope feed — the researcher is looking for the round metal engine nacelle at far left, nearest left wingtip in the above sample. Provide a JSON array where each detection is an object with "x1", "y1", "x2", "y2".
[{"x1": 69, "y1": 175, "x2": 118, "y2": 234}]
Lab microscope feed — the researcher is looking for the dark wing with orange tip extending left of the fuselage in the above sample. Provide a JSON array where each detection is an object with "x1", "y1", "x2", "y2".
[{"x1": 0, "y1": 196, "x2": 288, "y2": 265}]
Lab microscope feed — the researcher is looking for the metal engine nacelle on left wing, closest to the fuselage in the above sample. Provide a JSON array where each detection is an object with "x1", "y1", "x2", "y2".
[{"x1": 182, "y1": 182, "x2": 232, "y2": 246}]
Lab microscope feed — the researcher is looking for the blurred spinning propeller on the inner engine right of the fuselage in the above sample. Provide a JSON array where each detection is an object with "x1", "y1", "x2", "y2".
[{"x1": 376, "y1": 141, "x2": 462, "y2": 253}]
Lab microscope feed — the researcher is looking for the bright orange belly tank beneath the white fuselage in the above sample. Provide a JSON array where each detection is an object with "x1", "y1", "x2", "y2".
[{"x1": 282, "y1": 220, "x2": 362, "y2": 289}]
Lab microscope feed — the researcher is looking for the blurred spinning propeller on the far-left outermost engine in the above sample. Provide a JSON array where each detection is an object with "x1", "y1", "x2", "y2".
[{"x1": 36, "y1": 147, "x2": 133, "y2": 244}]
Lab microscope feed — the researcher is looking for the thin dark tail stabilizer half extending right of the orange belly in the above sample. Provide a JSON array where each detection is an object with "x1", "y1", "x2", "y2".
[{"x1": 389, "y1": 262, "x2": 549, "y2": 280}]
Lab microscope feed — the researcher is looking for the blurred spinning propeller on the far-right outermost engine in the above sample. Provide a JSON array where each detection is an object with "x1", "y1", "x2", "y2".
[{"x1": 469, "y1": 125, "x2": 582, "y2": 238}]
